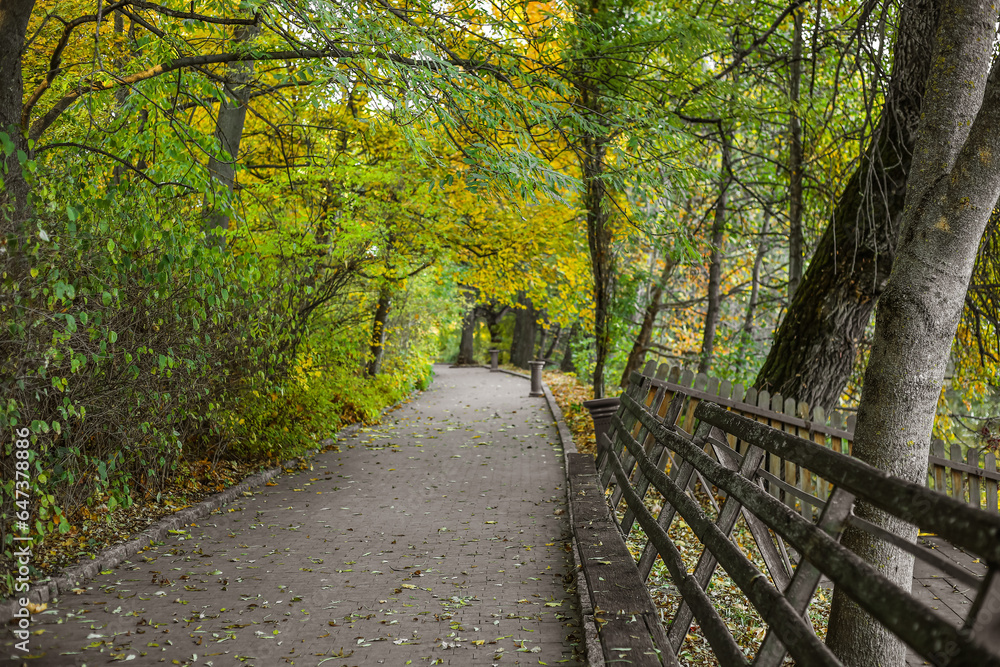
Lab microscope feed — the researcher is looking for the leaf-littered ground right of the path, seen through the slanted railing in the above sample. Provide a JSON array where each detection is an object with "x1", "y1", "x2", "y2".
[{"x1": 544, "y1": 371, "x2": 830, "y2": 667}]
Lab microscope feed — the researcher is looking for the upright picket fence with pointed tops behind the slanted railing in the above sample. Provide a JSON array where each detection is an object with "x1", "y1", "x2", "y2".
[{"x1": 656, "y1": 362, "x2": 1000, "y2": 513}]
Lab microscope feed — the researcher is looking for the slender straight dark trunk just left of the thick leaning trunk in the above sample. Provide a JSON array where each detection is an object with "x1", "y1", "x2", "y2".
[{"x1": 788, "y1": 9, "x2": 803, "y2": 303}]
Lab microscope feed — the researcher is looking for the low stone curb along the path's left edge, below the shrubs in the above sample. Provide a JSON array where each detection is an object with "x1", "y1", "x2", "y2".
[{"x1": 0, "y1": 424, "x2": 360, "y2": 625}]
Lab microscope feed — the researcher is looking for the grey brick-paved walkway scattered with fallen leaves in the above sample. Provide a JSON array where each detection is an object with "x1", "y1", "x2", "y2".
[{"x1": 0, "y1": 366, "x2": 583, "y2": 667}]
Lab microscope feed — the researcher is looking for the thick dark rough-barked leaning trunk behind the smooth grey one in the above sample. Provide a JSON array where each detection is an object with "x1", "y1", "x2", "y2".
[{"x1": 754, "y1": 0, "x2": 940, "y2": 408}]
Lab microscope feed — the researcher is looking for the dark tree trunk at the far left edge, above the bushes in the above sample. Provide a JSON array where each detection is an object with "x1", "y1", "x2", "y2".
[{"x1": 0, "y1": 0, "x2": 35, "y2": 266}]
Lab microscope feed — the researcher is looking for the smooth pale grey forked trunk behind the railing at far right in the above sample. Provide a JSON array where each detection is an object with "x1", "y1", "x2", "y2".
[{"x1": 827, "y1": 0, "x2": 1000, "y2": 667}]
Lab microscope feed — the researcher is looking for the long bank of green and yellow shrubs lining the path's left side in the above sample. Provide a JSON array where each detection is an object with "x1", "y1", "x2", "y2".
[{"x1": 0, "y1": 129, "x2": 448, "y2": 594}]
